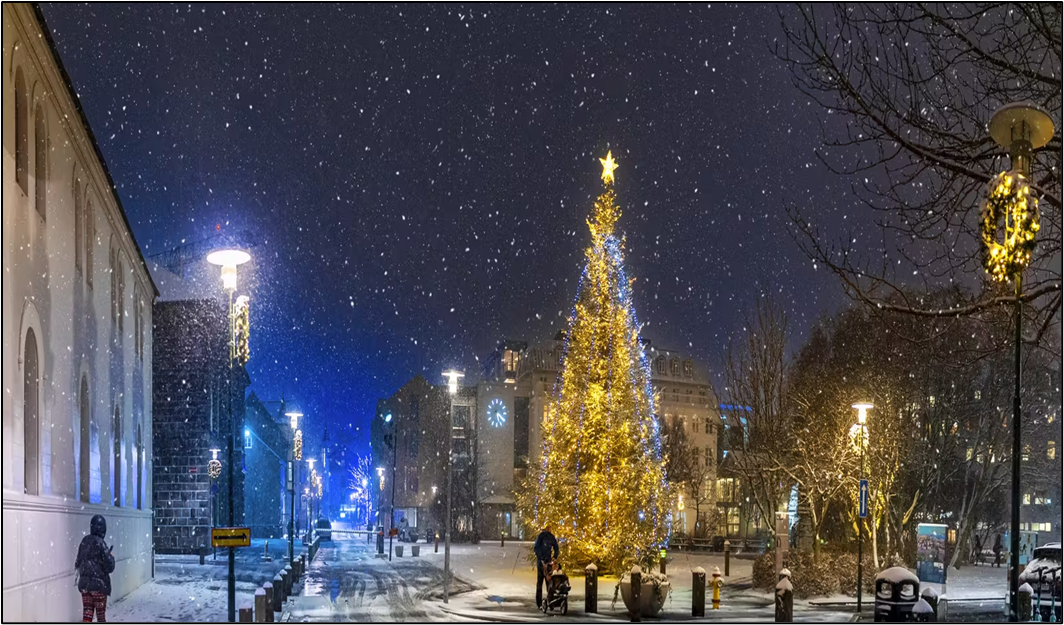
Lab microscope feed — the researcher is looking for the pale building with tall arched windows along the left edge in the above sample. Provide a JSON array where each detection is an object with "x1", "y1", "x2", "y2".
[{"x1": 2, "y1": 3, "x2": 157, "y2": 622}]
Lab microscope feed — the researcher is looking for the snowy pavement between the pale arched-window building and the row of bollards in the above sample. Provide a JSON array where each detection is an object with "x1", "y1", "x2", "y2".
[{"x1": 107, "y1": 540, "x2": 302, "y2": 623}]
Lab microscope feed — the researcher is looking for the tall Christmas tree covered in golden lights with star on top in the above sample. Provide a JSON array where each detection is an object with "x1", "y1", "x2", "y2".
[{"x1": 522, "y1": 153, "x2": 670, "y2": 573}]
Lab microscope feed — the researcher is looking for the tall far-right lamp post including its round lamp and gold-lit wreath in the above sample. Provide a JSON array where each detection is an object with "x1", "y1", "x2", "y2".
[{"x1": 981, "y1": 102, "x2": 1053, "y2": 622}]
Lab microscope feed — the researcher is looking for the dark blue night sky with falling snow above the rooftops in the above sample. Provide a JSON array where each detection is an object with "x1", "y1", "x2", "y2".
[{"x1": 43, "y1": 4, "x2": 867, "y2": 451}]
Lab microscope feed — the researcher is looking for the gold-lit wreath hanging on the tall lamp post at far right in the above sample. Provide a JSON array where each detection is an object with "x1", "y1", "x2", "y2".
[{"x1": 982, "y1": 171, "x2": 1040, "y2": 281}]
